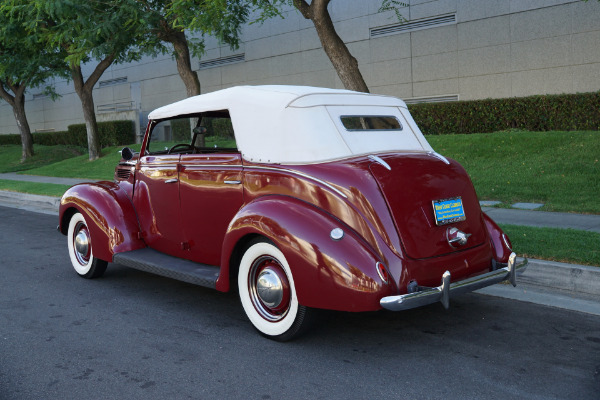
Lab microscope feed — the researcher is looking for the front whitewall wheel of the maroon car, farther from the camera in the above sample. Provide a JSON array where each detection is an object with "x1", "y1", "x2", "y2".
[{"x1": 67, "y1": 213, "x2": 108, "y2": 279}]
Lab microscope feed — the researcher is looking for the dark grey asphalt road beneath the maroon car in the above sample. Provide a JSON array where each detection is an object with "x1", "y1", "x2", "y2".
[{"x1": 0, "y1": 207, "x2": 600, "y2": 400}]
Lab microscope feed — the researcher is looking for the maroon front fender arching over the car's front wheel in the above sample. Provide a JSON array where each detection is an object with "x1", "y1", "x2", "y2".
[{"x1": 59, "y1": 181, "x2": 146, "y2": 262}]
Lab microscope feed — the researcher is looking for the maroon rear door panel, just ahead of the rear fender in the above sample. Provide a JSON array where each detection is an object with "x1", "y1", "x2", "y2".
[{"x1": 179, "y1": 152, "x2": 244, "y2": 265}]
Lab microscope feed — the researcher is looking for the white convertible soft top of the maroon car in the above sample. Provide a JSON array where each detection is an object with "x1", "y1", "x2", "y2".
[{"x1": 148, "y1": 85, "x2": 432, "y2": 164}]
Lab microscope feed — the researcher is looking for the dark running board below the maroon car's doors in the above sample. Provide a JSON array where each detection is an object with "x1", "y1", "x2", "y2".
[{"x1": 113, "y1": 247, "x2": 220, "y2": 289}]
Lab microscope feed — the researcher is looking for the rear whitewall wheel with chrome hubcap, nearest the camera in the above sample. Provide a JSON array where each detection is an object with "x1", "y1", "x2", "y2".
[{"x1": 238, "y1": 239, "x2": 315, "y2": 341}]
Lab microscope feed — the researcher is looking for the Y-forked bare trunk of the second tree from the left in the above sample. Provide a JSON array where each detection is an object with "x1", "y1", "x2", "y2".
[{"x1": 71, "y1": 54, "x2": 115, "y2": 161}]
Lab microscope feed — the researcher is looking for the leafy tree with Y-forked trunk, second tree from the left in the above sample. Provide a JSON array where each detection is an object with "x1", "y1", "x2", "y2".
[{"x1": 0, "y1": 0, "x2": 144, "y2": 160}]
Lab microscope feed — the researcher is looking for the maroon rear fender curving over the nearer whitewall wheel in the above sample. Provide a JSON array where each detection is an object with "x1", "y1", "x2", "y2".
[{"x1": 217, "y1": 196, "x2": 396, "y2": 311}]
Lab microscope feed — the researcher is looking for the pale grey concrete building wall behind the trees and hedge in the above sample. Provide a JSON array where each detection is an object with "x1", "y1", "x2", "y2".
[{"x1": 0, "y1": 0, "x2": 600, "y2": 133}]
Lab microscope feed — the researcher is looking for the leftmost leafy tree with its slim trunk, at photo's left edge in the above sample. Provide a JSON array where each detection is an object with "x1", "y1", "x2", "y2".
[{"x1": 0, "y1": 13, "x2": 64, "y2": 161}]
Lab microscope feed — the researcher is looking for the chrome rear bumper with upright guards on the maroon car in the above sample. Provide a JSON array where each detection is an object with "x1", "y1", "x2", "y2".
[{"x1": 379, "y1": 253, "x2": 527, "y2": 311}]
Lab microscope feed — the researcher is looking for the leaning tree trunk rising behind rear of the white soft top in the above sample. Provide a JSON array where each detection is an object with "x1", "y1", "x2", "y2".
[{"x1": 294, "y1": 0, "x2": 369, "y2": 93}]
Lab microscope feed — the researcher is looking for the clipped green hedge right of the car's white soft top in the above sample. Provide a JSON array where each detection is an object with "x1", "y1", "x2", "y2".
[{"x1": 409, "y1": 92, "x2": 600, "y2": 135}]
